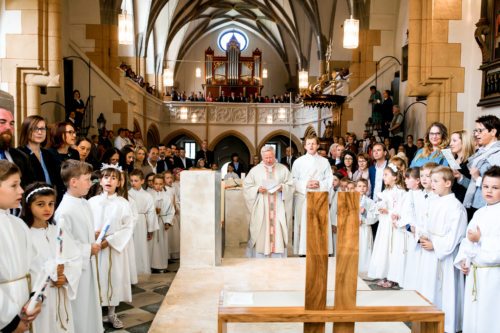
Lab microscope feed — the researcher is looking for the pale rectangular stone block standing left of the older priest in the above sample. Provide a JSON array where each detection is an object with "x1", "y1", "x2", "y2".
[{"x1": 180, "y1": 171, "x2": 222, "y2": 268}]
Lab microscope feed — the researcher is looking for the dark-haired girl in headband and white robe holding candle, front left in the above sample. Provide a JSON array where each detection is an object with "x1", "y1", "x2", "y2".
[{"x1": 22, "y1": 182, "x2": 82, "y2": 332}]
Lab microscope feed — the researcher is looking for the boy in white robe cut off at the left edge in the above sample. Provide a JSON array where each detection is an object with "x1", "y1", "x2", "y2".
[{"x1": 0, "y1": 160, "x2": 41, "y2": 332}]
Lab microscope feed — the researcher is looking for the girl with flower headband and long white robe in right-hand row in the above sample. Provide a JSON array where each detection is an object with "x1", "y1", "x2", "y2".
[{"x1": 368, "y1": 163, "x2": 405, "y2": 288}]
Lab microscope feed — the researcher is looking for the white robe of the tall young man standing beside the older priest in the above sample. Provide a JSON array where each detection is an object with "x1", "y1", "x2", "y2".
[{"x1": 292, "y1": 154, "x2": 333, "y2": 255}]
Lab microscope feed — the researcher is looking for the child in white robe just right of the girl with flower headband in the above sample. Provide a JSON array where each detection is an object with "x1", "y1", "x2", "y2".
[{"x1": 399, "y1": 167, "x2": 425, "y2": 290}]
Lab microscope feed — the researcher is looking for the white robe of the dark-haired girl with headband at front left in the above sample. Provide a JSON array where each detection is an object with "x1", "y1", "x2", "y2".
[{"x1": 30, "y1": 221, "x2": 82, "y2": 333}]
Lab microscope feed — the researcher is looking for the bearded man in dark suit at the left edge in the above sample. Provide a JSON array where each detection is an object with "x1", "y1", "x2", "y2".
[{"x1": 0, "y1": 91, "x2": 34, "y2": 188}]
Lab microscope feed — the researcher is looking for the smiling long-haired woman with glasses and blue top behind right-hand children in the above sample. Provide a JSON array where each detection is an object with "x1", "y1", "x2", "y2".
[{"x1": 410, "y1": 122, "x2": 449, "y2": 168}]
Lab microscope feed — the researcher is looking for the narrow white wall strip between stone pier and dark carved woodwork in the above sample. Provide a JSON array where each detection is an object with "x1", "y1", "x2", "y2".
[{"x1": 449, "y1": 0, "x2": 500, "y2": 130}]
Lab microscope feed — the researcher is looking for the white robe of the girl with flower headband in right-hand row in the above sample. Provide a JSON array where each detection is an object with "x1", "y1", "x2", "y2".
[{"x1": 368, "y1": 186, "x2": 404, "y2": 279}]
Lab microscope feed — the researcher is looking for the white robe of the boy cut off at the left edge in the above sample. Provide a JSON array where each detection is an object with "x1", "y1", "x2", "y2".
[{"x1": 0, "y1": 209, "x2": 36, "y2": 330}]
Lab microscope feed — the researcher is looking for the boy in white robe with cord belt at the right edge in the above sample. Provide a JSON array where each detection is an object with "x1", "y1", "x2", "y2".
[{"x1": 455, "y1": 166, "x2": 500, "y2": 333}]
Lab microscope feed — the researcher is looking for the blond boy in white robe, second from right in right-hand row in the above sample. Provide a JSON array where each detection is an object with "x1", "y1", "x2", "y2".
[{"x1": 419, "y1": 166, "x2": 467, "y2": 333}]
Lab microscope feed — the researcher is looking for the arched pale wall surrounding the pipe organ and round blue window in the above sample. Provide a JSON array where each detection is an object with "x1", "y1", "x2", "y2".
[{"x1": 174, "y1": 26, "x2": 288, "y2": 96}]
